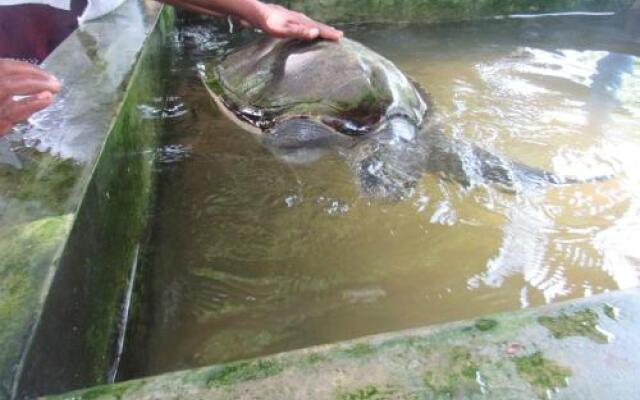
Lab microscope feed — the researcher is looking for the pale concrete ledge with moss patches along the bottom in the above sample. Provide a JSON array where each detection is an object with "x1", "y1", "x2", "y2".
[{"x1": 47, "y1": 289, "x2": 640, "y2": 400}]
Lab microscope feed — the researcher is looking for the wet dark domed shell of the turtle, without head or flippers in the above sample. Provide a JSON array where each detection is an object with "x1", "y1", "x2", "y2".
[{"x1": 205, "y1": 38, "x2": 427, "y2": 135}]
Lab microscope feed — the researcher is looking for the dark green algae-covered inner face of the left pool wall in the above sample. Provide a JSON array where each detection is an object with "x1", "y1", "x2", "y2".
[{"x1": 18, "y1": 3, "x2": 172, "y2": 397}]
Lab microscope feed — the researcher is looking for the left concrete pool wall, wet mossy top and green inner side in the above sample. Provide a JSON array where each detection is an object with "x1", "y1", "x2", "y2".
[{"x1": 0, "y1": 0, "x2": 172, "y2": 399}]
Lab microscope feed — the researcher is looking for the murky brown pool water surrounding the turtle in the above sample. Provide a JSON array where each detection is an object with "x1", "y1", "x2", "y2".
[{"x1": 122, "y1": 12, "x2": 640, "y2": 377}]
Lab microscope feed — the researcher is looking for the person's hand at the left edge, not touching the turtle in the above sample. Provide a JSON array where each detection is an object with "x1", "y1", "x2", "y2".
[{"x1": 0, "y1": 59, "x2": 60, "y2": 137}]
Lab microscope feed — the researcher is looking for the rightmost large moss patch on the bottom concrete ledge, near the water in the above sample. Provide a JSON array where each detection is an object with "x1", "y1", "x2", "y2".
[{"x1": 538, "y1": 309, "x2": 609, "y2": 343}]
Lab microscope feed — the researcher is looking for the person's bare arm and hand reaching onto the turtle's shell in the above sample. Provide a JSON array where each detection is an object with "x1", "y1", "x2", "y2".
[{"x1": 161, "y1": 0, "x2": 342, "y2": 40}]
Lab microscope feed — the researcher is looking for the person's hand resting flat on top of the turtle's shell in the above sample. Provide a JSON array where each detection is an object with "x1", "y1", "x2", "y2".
[{"x1": 254, "y1": 3, "x2": 342, "y2": 40}]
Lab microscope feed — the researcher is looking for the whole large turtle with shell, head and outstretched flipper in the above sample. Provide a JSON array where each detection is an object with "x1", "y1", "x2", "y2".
[{"x1": 202, "y1": 38, "x2": 584, "y2": 199}]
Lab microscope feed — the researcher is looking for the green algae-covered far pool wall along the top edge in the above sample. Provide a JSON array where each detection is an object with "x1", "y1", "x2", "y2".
[{"x1": 278, "y1": 0, "x2": 633, "y2": 23}]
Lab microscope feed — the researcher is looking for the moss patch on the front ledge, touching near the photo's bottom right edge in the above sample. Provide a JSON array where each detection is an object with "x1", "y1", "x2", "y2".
[{"x1": 514, "y1": 351, "x2": 571, "y2": 398}]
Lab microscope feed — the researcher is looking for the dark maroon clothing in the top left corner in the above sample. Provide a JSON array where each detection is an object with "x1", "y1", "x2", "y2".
[{"x1": 0, "y1": 0, "x2": 87, "y2": 63}]
